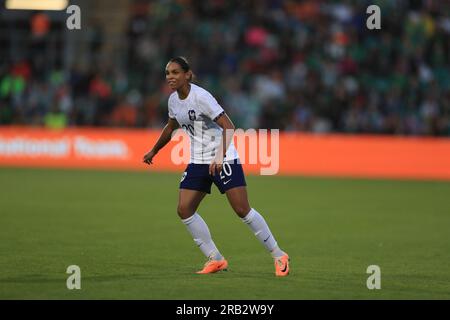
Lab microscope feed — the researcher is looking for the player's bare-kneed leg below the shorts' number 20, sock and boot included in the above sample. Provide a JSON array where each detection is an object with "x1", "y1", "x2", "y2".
[{"x1": 225, "y1": 186, "x2": 289, "y2": 276}]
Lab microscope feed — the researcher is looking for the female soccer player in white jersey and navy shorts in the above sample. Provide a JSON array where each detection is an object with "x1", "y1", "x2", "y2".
[{"x1": 143, "y1": 57, "x2": 289, "y2": 276}]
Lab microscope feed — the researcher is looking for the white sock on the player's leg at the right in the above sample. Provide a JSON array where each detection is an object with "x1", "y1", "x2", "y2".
[{"x1": 241, "y1": 208, "x2": 285, "y2": 258}]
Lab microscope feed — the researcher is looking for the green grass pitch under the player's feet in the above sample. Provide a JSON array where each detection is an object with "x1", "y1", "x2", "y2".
[{"x1": 0, "y1": 168, "x2": 450, "y2": 299}]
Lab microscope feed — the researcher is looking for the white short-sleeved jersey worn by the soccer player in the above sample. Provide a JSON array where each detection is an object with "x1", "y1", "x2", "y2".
[{"x1": 168, "y1": 83, "x2": 238, "y2": 164}]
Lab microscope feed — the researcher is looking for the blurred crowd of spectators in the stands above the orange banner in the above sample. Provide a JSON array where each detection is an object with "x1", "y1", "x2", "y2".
[{"x1": 0, "y1": 0, "x2": 450, "y2": 136}]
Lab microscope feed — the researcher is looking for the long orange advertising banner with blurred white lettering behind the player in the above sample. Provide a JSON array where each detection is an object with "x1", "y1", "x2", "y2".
[{"x1": 0, "y1": 127, "x2": 450, "y2": 180}]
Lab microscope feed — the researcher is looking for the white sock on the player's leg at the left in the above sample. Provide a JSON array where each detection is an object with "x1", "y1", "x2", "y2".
[{"x1": 181, "y1": 212, "x2": 223, "y2": 260}]
